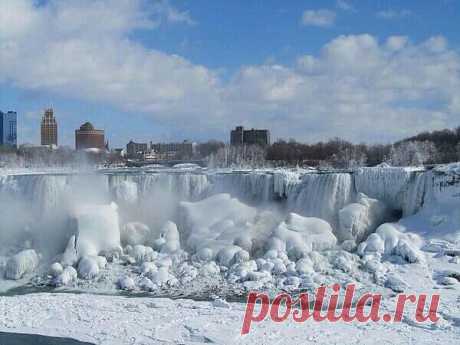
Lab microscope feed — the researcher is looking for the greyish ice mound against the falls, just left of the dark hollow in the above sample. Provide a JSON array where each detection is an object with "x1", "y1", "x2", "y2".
[{"x1": 336, "y1": 193, "x2": 390, "y2": 243}]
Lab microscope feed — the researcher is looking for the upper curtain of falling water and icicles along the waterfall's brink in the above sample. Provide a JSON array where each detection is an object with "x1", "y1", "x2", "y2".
[{"x1": 0, "y1": 167, "x2": 440, "y2": 223}]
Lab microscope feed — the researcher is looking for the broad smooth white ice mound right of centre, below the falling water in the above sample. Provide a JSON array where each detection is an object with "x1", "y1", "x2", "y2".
[{"x1": 269, "y1": 213, "x2": 337, "y2": 257}]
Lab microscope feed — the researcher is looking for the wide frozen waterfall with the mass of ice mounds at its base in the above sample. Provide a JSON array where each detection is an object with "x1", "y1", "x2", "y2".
[{"x1": 0, "y1": 165, "x2": 460, "y2": 292}]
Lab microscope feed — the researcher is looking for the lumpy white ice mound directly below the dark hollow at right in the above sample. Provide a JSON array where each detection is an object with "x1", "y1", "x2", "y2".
[{"x1": 358, "y1": 223, "x2": 424, "y2": 263}]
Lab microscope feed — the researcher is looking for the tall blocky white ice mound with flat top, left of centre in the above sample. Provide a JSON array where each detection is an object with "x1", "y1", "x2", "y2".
[{"x1": 73, "y1": 203, "x2": 120, "y2": 258}]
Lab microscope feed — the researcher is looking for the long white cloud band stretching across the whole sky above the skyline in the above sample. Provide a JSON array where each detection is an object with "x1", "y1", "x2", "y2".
[{"x1": 0, "y1": 0, "x2": 460, "y2": 142}]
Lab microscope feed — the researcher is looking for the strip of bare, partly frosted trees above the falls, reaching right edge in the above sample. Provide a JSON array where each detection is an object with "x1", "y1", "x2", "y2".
[{"x1": 198, "y1": 127, "x2": 460, "y2": 168}]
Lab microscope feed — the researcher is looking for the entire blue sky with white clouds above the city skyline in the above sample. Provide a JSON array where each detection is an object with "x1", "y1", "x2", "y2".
[{"x1": 0, "y1": 0, "x2": 460, "y2": 146}]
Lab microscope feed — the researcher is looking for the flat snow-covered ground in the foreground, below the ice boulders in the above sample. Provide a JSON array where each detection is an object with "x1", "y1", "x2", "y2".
[{"x1": 0, "y1": 288, "x2": 460, "y2": 345}]
